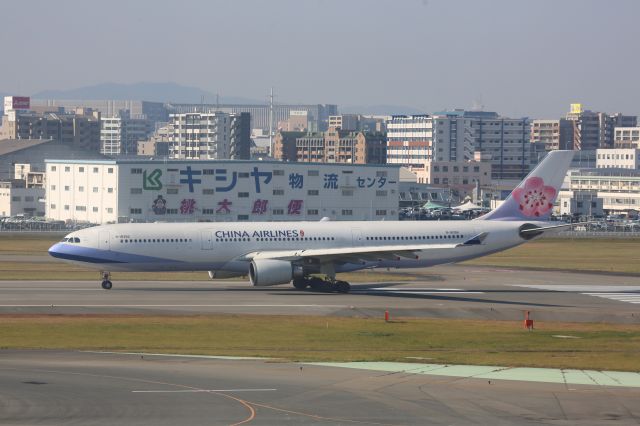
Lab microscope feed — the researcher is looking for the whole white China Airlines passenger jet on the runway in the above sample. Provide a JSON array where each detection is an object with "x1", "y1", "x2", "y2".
[{"x1": 49, "y1": 151, "x2": 573, "y2": 293}]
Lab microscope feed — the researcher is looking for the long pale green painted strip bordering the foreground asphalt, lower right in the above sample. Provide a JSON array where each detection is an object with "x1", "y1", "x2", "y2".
[{"x1": 310, "y1": 362, "x2": 640, "y2": 388}]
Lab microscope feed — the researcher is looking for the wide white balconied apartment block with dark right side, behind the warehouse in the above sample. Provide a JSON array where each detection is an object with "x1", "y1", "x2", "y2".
[{"x1": 168, "y1": 111, "x2": 251, "y2": 160}]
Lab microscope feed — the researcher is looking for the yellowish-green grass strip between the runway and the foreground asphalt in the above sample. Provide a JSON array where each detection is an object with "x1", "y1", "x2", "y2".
[{"x1": 0, "y1": 315, "x2": 640, "y2": 371}]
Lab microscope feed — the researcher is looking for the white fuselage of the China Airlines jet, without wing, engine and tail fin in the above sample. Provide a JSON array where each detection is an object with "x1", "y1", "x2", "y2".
[{"x1": 49, "y1": 220, "x2": 543, "y2": 274}]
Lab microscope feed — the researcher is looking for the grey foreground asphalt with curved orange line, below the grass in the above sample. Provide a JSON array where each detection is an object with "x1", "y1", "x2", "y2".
[{"x1": 0, "y1": 351, "x2": 640, "y2": 425}]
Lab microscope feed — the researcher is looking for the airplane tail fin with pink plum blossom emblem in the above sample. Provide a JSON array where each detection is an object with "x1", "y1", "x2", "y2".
[{"x1": 479, "y1": 151, "x2": 574, "y2": 221}]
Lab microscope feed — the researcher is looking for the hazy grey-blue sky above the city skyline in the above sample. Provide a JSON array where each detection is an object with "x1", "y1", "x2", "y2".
[{"x1": 0, "y1": 0, "x2": 640, "y2": 117}]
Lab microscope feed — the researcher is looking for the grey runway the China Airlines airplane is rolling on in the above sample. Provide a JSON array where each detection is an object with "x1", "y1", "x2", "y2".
[{"x1": 0, "y1": 265, "x2": 640, "y2": 323}]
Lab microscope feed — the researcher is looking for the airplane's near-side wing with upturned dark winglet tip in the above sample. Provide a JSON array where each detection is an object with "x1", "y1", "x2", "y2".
[{"x1": 236, "y1": 232, "x2": 488, "y2": 263}]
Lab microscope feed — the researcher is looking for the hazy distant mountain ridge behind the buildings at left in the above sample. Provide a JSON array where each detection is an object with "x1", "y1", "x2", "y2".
[{"x1": 31, "y1": 82, "x2": 264, "y2": 104}]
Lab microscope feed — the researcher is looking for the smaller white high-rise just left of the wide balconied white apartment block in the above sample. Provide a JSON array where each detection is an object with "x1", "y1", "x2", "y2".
[{"x1": 100, "y1": 111, "x2": 152, "y2": 156}]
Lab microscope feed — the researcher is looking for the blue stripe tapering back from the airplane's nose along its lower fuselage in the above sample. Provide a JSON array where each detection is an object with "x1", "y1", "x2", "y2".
[{"x1": 49, "y1": 243, "x2": 184, "y2": 263}]
